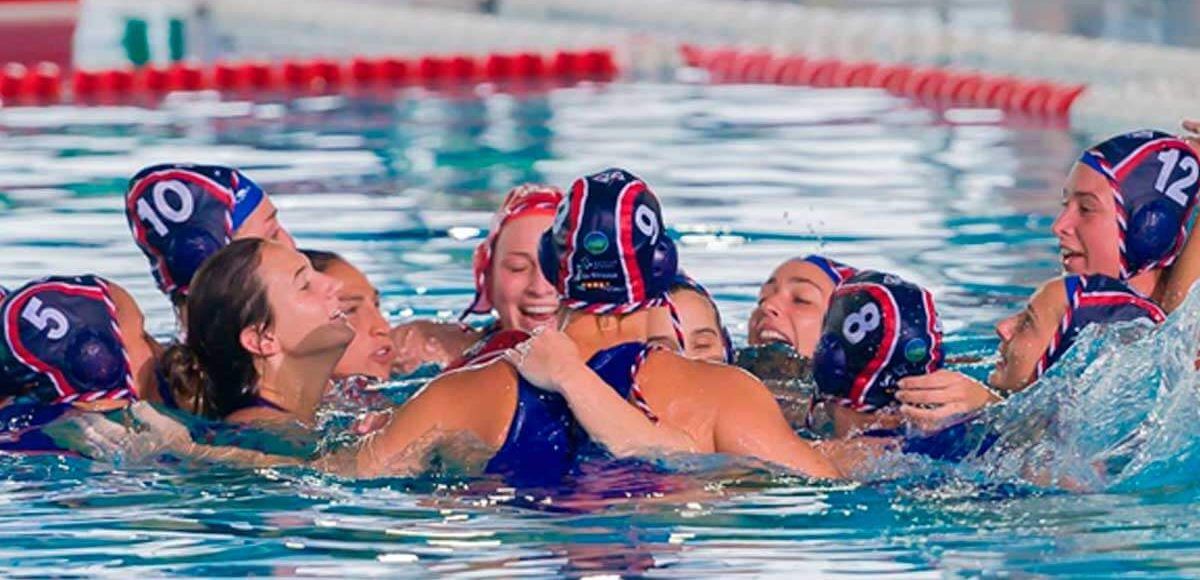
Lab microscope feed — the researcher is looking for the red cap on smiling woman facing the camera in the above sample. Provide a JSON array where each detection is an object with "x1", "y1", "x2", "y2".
[{"x1": 460, "y1": 184, "x2": 563, "y2": 319}]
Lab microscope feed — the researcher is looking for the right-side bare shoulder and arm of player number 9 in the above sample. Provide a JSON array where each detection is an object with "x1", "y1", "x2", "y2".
[{"x1": 638, "y1": 352, "x2": 841, "y2": 478}]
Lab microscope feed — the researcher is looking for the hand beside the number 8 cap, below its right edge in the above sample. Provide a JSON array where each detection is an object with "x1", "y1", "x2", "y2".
[{"x1": 896, "y1": 370, "x2": 1000, "y2": 433}]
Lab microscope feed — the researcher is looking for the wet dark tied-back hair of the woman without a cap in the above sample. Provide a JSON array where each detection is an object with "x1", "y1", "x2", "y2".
[{"x1": 161, "y1": 238, "x2": 275, "y2": 419}]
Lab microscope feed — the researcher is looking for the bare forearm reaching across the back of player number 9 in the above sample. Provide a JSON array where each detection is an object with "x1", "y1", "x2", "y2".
[{"x1": 558, "y1": 366, "x2": 700, "y2": 458}]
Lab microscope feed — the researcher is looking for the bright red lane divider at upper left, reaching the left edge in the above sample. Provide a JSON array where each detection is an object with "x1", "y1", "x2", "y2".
[{"x1": 0, "y1": 49, "x2": 618, "y2": 104}]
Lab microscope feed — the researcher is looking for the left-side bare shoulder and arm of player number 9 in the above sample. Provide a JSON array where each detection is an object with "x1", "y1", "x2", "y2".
[{"x1": 345, "y1": 360, "x2": 517, "y2": 477}]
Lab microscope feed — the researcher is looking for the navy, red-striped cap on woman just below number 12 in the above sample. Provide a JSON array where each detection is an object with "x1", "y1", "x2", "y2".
[{"x1": 1034, "y1": 274, "x2": 1166, "y2": 378}]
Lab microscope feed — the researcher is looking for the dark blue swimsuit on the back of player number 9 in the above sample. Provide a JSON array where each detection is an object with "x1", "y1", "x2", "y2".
[{"x1": 486, "y1": 342, "x2": 647, "y2": 485}]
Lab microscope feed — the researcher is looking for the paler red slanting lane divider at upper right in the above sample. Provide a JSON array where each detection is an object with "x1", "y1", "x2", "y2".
[{"x1": 679, "y1": 44, "x2": 1086, "y2": 118}]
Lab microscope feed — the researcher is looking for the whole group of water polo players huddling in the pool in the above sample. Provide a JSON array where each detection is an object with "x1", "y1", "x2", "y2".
[{"x1": 0, "y1": 123, "x2": 1200, "y2": 480}]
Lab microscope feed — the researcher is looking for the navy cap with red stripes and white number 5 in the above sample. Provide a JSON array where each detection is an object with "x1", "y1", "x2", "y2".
[{"x1": 0, "y1": 276, "x2": 137, "y2": 403}]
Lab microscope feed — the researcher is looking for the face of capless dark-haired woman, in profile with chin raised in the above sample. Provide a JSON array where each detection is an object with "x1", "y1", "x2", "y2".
[{"x1": 244, "y1": 244, "x2": 354, "y2": 357}]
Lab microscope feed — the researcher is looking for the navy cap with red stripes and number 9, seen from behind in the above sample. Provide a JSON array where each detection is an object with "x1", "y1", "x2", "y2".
[{"x1": 538, "y1": 169, "x2": 679, "y2": 313}]
